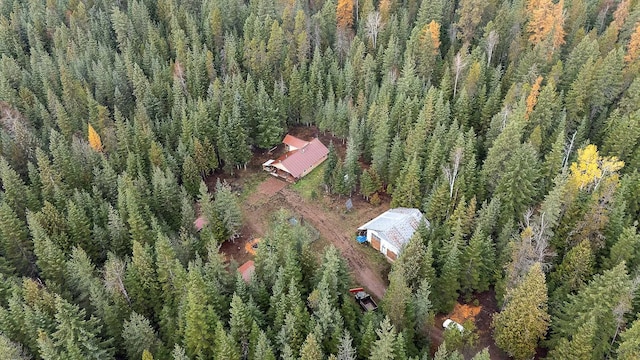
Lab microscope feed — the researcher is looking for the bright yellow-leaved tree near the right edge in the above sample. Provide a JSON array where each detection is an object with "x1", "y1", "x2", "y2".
[{"x1": 568, "y1": 144, "x2": 624, "y2": 191}]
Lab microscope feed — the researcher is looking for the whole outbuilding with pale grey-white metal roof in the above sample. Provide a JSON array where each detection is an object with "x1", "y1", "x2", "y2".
[{"x1": 356, "y1": 208, "x2": 429, "y2": 261}]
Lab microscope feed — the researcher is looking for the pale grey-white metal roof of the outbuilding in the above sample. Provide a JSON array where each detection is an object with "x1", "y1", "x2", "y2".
[{"x1": 358, "y1": 208, "x2": 429, "y2": 249}]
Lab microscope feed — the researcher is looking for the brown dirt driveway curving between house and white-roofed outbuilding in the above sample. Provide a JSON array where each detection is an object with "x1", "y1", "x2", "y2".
[{"x1": 236, "y1": 177, "x2": 388, "y2": 299}]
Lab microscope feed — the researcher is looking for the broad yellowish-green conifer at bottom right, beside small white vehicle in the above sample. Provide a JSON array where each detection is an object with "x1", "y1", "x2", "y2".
[{"x1": 492, "y1": 263, "x2": 550, "y2": 359}]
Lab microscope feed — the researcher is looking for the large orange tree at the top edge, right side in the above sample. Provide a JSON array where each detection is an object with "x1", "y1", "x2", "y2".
[{"x1": 527, "y1": 0, "x2": 564, "y2": 50}]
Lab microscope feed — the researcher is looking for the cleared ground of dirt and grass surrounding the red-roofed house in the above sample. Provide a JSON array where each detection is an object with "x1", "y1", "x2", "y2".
[{"x1": 218, "y1": 126, "x2": 390, "y2": 299}]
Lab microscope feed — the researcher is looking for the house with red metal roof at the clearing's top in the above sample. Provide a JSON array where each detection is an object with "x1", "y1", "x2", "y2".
[{"x1": 262, "y1": 135, "x2": 329, "y2": 182}]
